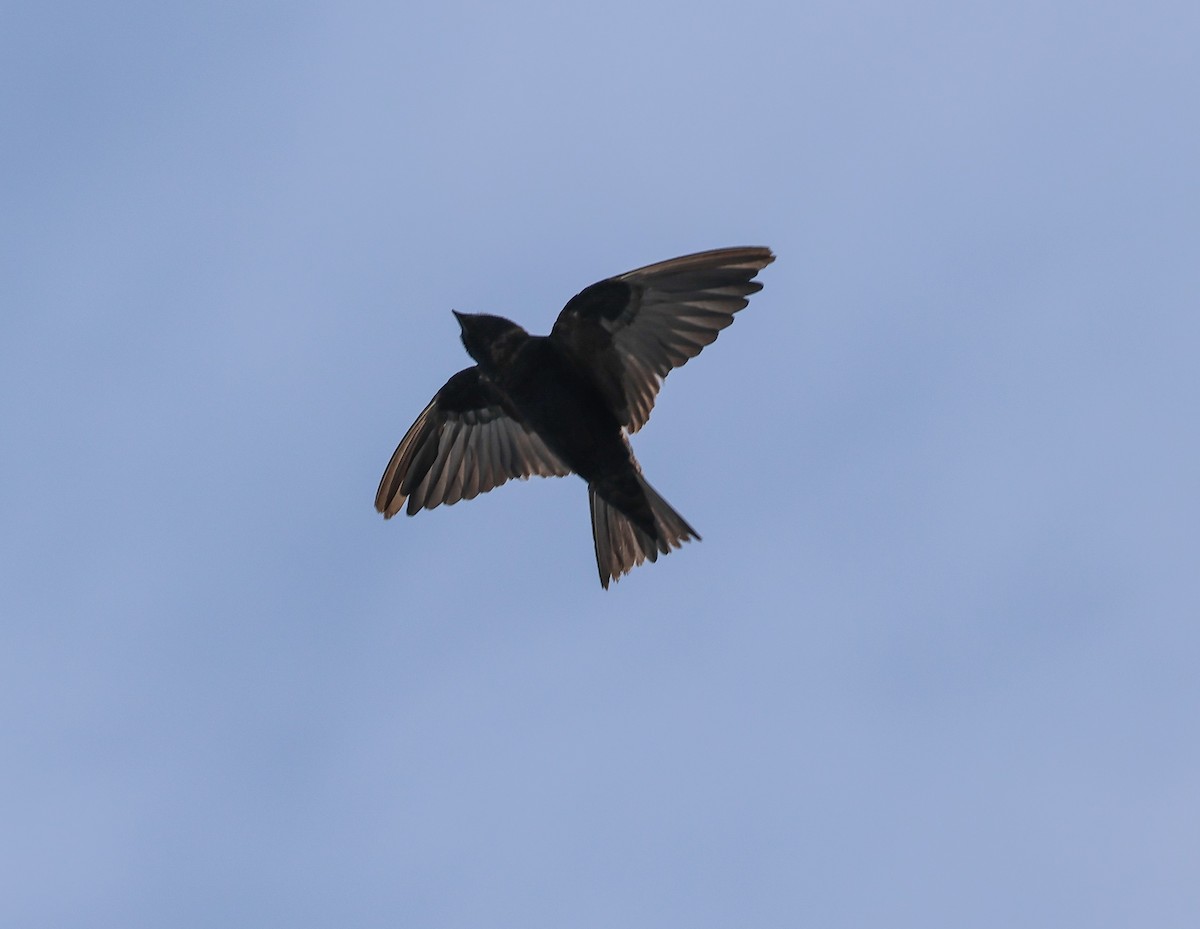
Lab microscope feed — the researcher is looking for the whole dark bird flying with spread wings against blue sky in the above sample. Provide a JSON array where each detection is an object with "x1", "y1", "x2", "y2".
[{"x1": 376, "y1": 247, "x2": 775, "y2": 588}]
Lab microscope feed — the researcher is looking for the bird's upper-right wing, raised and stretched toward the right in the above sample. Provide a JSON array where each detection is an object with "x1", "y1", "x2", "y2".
[{"x1": 551, "y1": 247, "x2": 775, "y2": 432}]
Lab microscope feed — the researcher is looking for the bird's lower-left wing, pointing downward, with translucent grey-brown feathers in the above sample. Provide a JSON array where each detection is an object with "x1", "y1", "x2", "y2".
[{"x1": 376, "y1": 367, "x2": 571, "y2": 517}]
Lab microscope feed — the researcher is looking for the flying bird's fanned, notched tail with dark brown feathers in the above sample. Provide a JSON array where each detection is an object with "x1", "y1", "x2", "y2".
[{"x1": 588, "y1": 474, "x2": 700, "y2": 589}]
